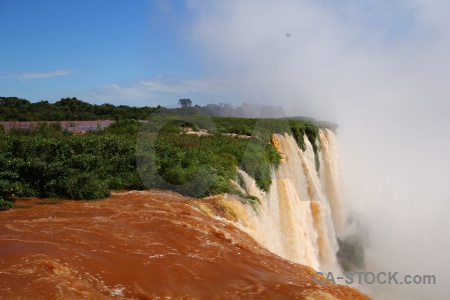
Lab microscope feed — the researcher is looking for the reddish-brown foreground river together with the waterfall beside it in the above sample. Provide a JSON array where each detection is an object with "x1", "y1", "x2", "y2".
[{"x1": 0, "y1": 130, "x2": 370, "y2": 299}]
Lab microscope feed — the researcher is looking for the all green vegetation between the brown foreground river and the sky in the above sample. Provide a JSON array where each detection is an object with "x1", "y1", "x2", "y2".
[{"x1": 0, "y1": 98, "x2": 326, "y2": 209}]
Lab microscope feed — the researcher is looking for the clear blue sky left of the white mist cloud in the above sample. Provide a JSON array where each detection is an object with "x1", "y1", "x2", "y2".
[{"x1": 0, "y1": 0, "x2": 206, "y2": 104}]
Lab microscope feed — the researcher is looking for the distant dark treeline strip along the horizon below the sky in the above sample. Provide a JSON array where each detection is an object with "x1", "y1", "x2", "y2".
[{"x1": 0, "y1": 97, "x2": 337, "y2": 130}]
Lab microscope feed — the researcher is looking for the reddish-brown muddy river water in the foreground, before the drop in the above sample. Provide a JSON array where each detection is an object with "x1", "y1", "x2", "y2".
[{"x1": 0, "y1": 191, "x2": 369, "y2": 299}]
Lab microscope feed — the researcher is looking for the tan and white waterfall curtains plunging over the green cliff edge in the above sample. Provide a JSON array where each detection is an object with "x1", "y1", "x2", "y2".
[{"x1": 202, "y1": 129, "x2": 344, "y2": 270}]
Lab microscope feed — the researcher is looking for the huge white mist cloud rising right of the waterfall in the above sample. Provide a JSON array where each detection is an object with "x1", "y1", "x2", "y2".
[{"x1": 185, "y1": 0, "x2": 450, "y2": 299}]
